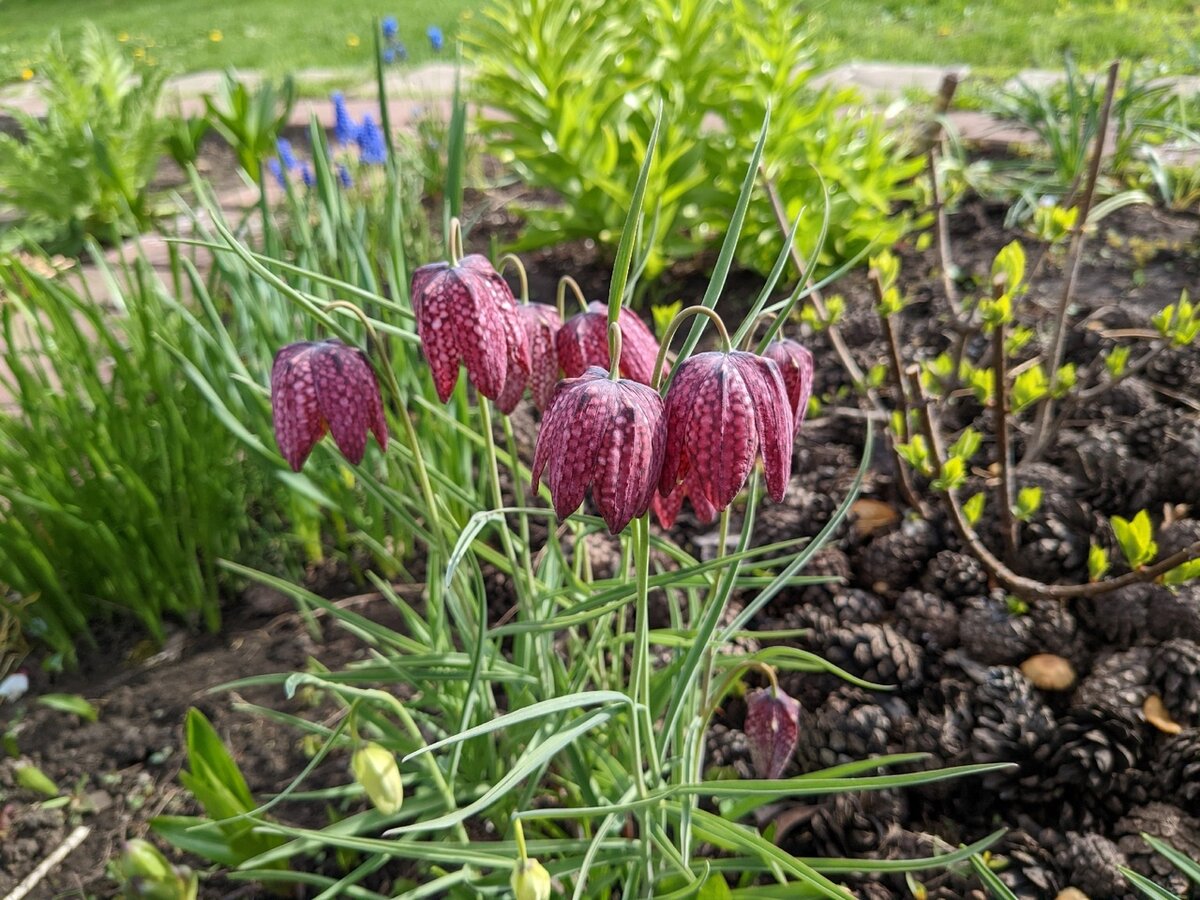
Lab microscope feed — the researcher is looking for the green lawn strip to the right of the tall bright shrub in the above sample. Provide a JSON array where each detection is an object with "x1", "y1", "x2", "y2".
[{"x1": 802, "y1": 0, "x2": 1200, "y2": 74}]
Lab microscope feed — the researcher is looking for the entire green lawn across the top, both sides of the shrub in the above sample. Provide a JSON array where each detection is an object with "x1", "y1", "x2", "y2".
[{"x1": 9, "y1": 0, "x2": 1200, "y2": 82}]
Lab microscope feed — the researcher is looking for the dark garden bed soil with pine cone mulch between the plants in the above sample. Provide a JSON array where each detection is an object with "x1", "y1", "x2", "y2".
[{"x1": 9, "y1": 192, "x2": 1200, "y2": 900}]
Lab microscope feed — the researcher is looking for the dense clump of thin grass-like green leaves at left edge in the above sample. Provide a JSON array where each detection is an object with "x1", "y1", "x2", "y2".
[{"x1": 0, "y1": 250, "x2": 282, "y2": 662}]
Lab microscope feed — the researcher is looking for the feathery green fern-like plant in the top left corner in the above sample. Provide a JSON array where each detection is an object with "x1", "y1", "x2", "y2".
[{"x1": 0, "y1": 25, "x2": 164, "y2": 252}]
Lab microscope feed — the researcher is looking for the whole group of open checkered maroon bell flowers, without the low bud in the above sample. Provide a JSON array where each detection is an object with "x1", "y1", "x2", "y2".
[{"x1": 271, "y1": 247, "x2": 812, "y2": 534}]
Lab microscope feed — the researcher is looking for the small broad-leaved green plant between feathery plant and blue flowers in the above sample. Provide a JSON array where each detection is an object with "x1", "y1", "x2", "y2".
[{"x1": 204, "y1": 68, "x2": 296, "y2": 184}]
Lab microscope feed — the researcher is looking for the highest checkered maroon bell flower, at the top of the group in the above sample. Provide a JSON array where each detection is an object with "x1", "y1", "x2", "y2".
[{"x1": 412, "y1": 253, "x2": 529, "y2": 412}]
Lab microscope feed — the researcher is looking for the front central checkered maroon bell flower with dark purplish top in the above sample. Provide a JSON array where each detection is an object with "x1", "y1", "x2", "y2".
[{"x1": 533, "y1": 367, "x2": 667, "y2": 534}]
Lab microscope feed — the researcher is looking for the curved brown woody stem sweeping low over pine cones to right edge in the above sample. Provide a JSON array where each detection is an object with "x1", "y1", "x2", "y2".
[{"x1": 906, "y1": 366, "x2": 1200, "y2": 600}]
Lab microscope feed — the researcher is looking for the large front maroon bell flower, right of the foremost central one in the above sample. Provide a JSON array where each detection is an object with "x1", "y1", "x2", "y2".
[{"x1": 655, "y1": 350, "x2": 793, "y2": 528}]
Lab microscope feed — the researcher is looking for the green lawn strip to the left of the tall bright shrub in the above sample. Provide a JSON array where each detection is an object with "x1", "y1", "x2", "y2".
[{"x1": 0, "y1": 0, "x2": 469, "y2": 83}]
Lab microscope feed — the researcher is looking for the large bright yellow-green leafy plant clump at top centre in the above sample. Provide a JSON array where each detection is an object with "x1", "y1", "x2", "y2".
[{"x1": 466, "y1": 0, "x2": 919, "y2": 275}]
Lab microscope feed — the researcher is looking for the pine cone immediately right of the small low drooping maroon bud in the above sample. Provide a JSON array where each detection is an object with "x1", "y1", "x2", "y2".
[{"x1": 796, "y1": 685, "x2": 916, "y2": 772}]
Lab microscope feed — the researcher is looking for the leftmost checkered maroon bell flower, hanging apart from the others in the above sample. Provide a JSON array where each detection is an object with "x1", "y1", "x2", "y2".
[{"x1": 271, "y1": 341, "x2": 388, "y2": 472}]
